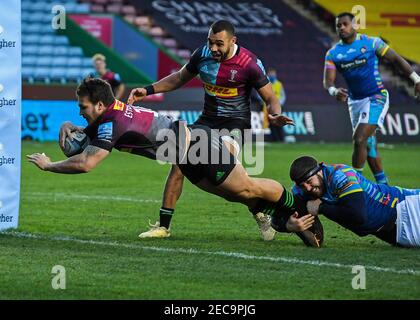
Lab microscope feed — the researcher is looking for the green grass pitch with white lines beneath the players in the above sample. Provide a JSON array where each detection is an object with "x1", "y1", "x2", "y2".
[{"x1": 0, "y1": 142, "x2": 420, "y2": 300}]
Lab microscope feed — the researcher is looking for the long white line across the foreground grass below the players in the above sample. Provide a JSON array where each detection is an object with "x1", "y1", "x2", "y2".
[{"x1": 0, "y1": 230, "x2": 420, "y2": 276}]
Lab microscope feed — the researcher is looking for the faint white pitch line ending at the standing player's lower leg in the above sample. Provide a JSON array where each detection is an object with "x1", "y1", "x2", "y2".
[{"x1": 22, "y1": 192, "x2": 161, "y2": 203}]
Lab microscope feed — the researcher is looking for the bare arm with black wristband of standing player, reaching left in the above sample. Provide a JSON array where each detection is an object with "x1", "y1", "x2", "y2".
[{"x1": 127, "y1": 66, "x2": 196, "y2": 104}]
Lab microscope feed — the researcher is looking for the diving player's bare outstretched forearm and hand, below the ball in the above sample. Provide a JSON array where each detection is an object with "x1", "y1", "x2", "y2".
[{"x1": 26, "y1": 145, "x2": 109, "y2": 174}]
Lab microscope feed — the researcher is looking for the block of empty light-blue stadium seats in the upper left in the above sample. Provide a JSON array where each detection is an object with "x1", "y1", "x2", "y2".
[{"x1": 22, "y1": 0, "x2": 93, "y2": 84}]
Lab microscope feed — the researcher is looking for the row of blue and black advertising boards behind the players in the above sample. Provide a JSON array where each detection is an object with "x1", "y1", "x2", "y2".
[{"x1": 22, "y1": 100, "x2": 420, "y2": 143}]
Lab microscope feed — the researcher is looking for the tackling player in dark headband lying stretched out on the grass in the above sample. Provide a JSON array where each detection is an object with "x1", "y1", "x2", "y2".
[{"x1": 290, "y1": 156, "x2": 420, "y2": 247}]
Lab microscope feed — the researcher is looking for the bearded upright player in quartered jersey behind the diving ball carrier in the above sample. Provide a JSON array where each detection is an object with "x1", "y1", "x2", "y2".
[{"x1": 128, "y1": 20, "x2": 292, "y2": 240}]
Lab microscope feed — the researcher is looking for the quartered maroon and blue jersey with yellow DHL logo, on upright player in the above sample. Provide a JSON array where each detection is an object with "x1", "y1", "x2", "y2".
[{"x1": 186, "y1": 45, "x2": 269, "y2": 122}]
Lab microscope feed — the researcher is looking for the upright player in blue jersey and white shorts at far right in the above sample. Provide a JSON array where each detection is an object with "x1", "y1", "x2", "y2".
[{"x1": 324, "y1": 12, "x2": 420, "y2": 183}]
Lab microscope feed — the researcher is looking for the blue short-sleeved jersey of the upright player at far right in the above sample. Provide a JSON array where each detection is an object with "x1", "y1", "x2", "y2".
[{"x1": 325, "y1": 33, "x2": 389, "y2": 99}]
